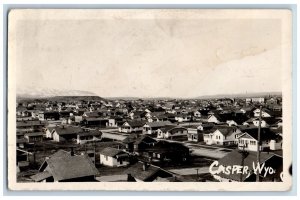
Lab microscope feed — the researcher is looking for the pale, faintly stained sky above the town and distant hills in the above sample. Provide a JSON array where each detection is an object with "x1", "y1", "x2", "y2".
[{"x1": 15, "y1": 11, "x2": 282, "y2": 98}]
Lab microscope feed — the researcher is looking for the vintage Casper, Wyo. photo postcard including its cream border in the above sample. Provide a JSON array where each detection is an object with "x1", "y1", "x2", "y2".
[{"x1": 8, "y1": 9, "x2": 292, "y2": 191}]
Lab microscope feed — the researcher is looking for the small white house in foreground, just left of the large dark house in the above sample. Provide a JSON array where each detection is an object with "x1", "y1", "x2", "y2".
[{"x1": 100, "y1": 147, "x2": 129, "y2": 167}]
